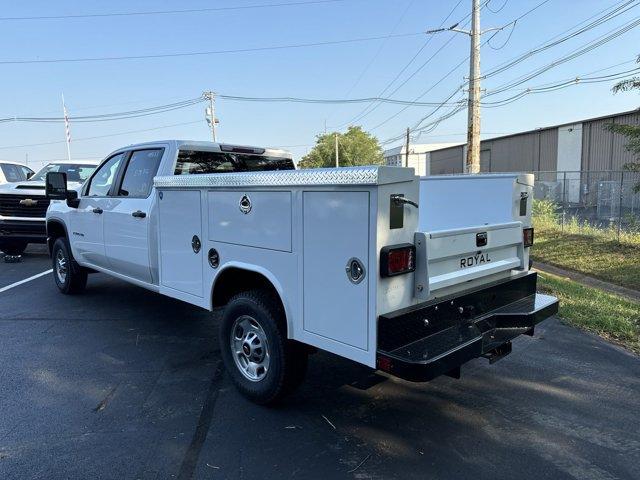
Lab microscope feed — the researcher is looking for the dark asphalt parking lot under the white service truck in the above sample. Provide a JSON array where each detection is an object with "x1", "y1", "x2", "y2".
[{"x1": 0, "y1": 247, "x2": 640, "y2": 480}]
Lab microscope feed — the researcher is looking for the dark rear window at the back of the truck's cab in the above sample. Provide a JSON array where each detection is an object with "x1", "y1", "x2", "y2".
[{"x1": 174, "y1": 150, "x2": 295, "y2": 175}]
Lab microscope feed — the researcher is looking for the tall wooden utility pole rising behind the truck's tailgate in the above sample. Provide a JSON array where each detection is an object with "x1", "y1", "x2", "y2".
[{"x1": 467, "y1": 0, "x2": 482, "y2": 173}]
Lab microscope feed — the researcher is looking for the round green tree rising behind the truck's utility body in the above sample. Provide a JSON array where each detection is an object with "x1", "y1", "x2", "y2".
[{"x1": 298, "y1": 127, "x2": 384, "y2": 168}]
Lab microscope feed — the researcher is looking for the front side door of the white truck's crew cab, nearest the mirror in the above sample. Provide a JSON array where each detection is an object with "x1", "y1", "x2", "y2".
[{"x1": 69, "y1": 153, "x2": 124, "y2": 268}]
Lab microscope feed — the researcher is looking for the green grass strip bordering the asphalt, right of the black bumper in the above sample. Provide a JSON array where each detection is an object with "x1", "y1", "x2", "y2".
[{"x1": 538, "y1": 272, "x2": 640, "y2": 353}]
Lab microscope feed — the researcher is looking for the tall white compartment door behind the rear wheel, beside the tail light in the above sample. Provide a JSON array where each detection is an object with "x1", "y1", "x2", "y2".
[{"x1": 303, "y1": 191, "x2": 376, "y2": 361}]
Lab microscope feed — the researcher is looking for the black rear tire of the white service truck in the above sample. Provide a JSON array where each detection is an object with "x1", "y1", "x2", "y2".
[{"x1": 220, "y1": 290, "x2": 308, "y2": 405}]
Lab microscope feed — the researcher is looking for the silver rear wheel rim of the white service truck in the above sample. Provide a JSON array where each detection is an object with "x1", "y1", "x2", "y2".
[{"x1": 230, "y1": 315, "x2": 271, "y2": 382}]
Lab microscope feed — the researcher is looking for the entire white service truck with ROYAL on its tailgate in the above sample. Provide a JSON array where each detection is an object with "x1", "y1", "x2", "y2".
[{"x1": 47, "y1": 140, "x2": 558, "y2": 404}]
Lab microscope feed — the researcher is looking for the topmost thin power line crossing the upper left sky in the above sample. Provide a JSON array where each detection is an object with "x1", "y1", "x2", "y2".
[{"x1": 0, "y1": 0, "x2": 350, "y2": 22}]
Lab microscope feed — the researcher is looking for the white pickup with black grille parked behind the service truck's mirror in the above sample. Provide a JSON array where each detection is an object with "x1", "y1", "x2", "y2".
[{"x1": 0, "y1": 161, "x2": 97, "y2": 255}]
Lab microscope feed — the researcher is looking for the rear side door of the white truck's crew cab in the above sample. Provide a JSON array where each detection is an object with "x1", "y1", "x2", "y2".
[{"x1": 104, "y1": 148, "x2": 164, "y2": 283}]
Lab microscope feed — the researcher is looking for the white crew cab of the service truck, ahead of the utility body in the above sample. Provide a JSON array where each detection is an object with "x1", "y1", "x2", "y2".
[{"x1": 47, "y1": 140, "x2": 295, "y2": 290}]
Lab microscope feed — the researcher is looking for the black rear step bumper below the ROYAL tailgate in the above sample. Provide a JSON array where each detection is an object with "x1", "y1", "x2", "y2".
[{"x1": 377, "y1": 272, "x2": 558, "y2": 382}]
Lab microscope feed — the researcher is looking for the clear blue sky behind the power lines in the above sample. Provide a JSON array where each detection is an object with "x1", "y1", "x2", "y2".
[{"x1": 0, "y1": 0, "x2": 640, "y2": 171}]
